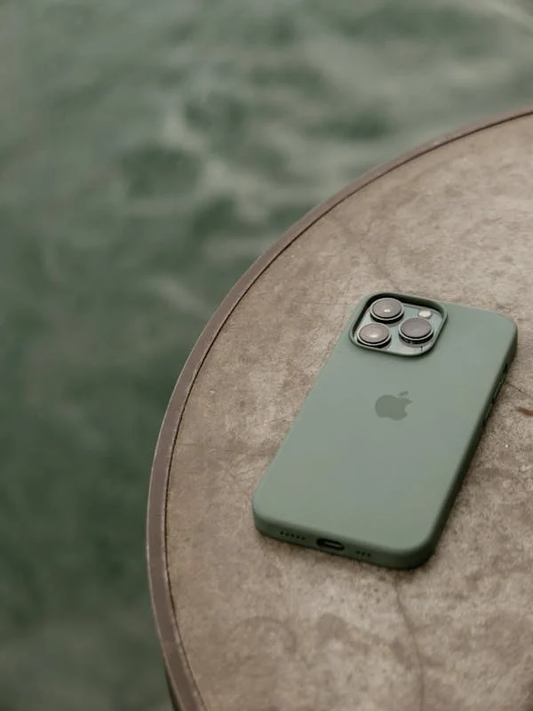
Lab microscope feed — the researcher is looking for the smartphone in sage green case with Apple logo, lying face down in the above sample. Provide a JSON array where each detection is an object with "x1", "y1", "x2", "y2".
[{"x1": 253, "y1": 293, "x2": 517, "y2": 568}]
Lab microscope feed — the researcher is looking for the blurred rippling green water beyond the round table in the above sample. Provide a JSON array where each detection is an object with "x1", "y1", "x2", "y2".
[{"x1": 0, "y1": 0, "x2": 533, "y2": 711}]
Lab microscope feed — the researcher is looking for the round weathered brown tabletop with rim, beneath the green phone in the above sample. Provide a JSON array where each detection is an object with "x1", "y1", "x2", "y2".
[{"x1": 148, "y1": 110, "x2": 533, "y2": 711}]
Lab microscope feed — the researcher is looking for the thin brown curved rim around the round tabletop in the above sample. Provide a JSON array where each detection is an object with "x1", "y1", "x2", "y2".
[{"x1": 146, "y1": 106, "x2": 533, "y2": 711}]
